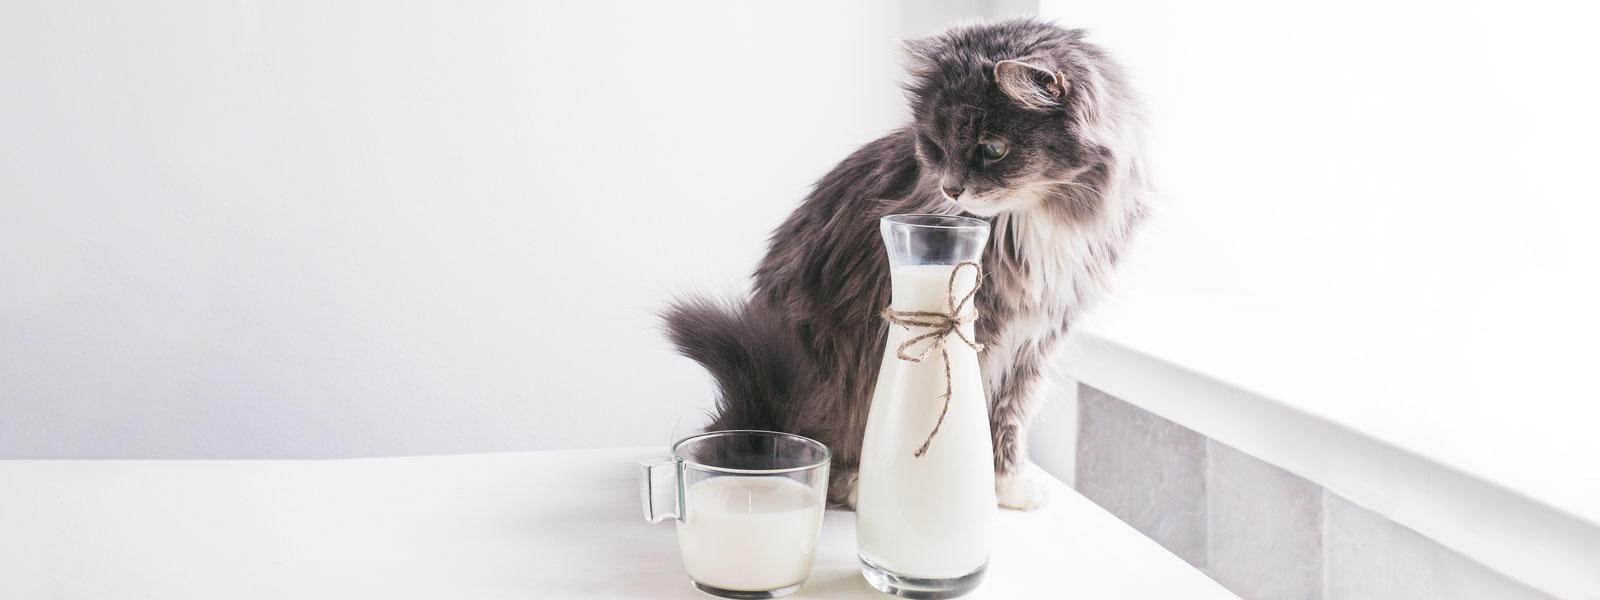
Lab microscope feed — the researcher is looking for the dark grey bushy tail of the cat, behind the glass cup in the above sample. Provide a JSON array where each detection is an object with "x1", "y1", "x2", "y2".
[{"x1": 662, "y1": 296, "x2": 808, "y2": 430}]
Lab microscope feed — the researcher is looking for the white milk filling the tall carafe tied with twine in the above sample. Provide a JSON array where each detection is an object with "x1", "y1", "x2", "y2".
[{"x1": 856, "y1": 266, "x2": 995, "y2": 578}]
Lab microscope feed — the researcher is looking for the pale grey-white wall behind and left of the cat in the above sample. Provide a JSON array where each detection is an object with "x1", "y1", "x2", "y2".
[{"x1": 0, "y1": 0, "x2": 1014, "y2": 458}]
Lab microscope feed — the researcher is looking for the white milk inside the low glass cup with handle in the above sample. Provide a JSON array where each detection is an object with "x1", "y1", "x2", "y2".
[{"x1": 678, "y1": 475, "x2": 822, "y2": 590}]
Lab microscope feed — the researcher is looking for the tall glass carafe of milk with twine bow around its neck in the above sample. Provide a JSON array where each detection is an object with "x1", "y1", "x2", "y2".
[{"x1": 856, "y1": 214, "x2": 995, "y2": 598}]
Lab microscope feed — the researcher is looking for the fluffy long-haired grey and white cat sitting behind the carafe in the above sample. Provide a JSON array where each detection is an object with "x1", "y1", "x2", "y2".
[{"x1": 666, "y1": 19, "x2": 1147, "y2": 509}]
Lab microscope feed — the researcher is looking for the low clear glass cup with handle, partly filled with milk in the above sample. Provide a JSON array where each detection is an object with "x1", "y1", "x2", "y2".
[{"x1": 638, "y1": 430, "x2": 832, "y2": 598}]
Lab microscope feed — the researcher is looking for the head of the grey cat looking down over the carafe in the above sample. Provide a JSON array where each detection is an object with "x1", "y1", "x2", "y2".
[{"x1": 902, "y1": 19, "x2": 1139, "y2": 219}]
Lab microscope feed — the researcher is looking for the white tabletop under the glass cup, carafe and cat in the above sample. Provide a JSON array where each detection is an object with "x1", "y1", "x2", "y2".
[{"x1": 0, "y1": 448, "x2": 1234, "y2": 598}]
